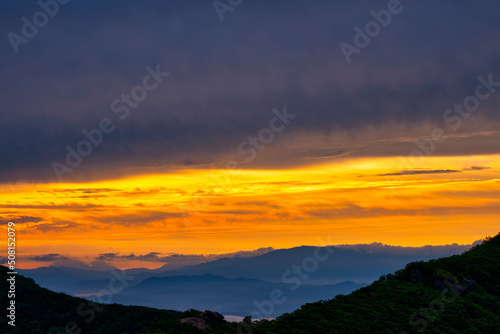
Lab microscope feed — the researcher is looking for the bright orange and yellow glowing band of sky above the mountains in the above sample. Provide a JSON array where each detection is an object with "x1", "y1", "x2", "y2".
[{"x1": 0, "y1": 155, "x2": 500, "y2": 268}]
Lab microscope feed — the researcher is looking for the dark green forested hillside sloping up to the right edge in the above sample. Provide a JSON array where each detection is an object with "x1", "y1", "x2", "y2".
[{"x1": 250, "y1": 234, "x2": 500, "y2": 334}]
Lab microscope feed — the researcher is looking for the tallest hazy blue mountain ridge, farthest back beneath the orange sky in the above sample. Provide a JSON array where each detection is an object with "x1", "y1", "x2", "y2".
[{"x1": 162, "y1": 244, "x2": 471, "y2": 284}]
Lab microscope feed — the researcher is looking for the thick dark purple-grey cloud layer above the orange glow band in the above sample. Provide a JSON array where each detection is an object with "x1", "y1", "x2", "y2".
[{"x1": 0, "y1": 0, "x2": 500, "y2": 182}]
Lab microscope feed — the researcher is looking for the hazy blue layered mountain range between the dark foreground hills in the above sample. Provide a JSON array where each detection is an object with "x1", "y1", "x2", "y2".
[{"x1": 14, "y1": 243, "x2": 471, "y2": 317}]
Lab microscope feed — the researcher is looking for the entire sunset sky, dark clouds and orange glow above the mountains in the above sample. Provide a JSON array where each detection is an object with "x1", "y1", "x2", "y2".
[{"x1": 0, "y1": 0, "x2": 500, "y2": 268}]
